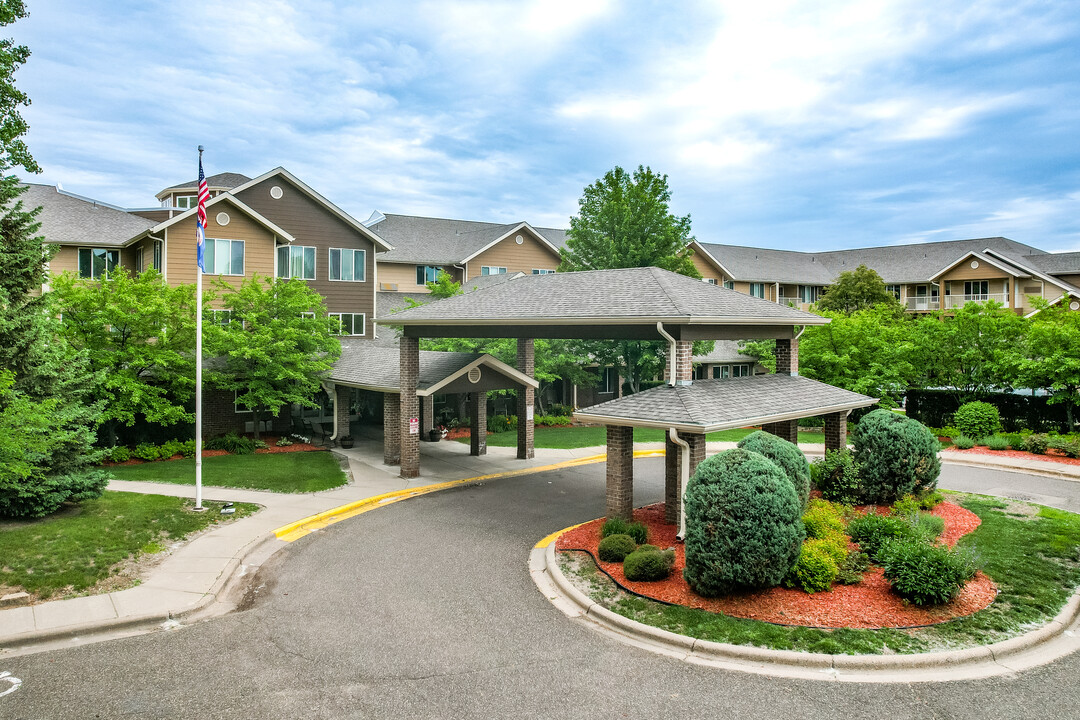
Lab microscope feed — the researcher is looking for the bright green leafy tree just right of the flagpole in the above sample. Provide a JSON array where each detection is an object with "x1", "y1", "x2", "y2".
[{"x1": 203, "y1": 275, "x2": 341, "y2": 438}]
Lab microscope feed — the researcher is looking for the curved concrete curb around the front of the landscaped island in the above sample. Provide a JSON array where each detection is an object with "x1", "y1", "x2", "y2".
[{"x1": 543, "y1": 541, "x2": 1080, "y2": 682}]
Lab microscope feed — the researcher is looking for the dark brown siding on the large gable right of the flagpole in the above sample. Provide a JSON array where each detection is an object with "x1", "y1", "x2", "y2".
[{"x1": 237, "y1": 175, "x2": 378, "y2": 337}]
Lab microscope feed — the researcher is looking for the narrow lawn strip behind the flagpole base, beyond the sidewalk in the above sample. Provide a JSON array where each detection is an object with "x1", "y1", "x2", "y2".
[{"x1": 109, "y1": 450, "x2": 348, "y2": 492}]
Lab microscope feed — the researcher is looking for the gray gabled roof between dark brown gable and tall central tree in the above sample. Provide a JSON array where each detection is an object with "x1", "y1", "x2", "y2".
[{"x1": 370, "y1": 214, "x2": 565, "y2": 266}]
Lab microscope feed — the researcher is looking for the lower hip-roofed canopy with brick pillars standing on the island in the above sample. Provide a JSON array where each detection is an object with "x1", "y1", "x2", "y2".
[{"x1": 573, "y1": 375, "x2": 877, "y2": 536}]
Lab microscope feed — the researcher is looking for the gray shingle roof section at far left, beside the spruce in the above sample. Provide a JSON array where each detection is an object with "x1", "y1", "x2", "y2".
[{"x1": 19, "y1": 184, "x2": 158, "y2": 247}]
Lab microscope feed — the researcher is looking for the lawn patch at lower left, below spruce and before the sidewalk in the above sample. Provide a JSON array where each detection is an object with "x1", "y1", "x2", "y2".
[{"x1": 0, "y1": 491, "x2": 257, "y2": 598}]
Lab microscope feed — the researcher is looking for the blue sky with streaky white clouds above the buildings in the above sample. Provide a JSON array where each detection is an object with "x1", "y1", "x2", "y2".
[{"x1": 5, "y1": 0, "x2": 1080, "y2": 250}]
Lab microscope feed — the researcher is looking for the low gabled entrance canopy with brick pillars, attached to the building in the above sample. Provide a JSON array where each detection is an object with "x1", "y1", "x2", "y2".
[{"x1": 327, "y1": 340, "x2": 538, "y2": 465}]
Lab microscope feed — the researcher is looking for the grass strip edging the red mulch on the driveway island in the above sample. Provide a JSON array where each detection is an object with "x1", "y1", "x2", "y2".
[{"x1": 565, "y1": 493, "x2": 1080, "y2": 654}]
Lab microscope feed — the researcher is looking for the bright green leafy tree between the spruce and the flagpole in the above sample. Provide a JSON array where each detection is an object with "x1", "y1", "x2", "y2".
[{"x1": 53, "y1": 268, "x2": 195, "y2": 445}]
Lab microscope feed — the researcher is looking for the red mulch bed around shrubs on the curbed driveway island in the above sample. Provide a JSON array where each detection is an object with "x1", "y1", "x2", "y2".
[{"x1": 555, "y1": 503, "x2": 997, "y2": 629}]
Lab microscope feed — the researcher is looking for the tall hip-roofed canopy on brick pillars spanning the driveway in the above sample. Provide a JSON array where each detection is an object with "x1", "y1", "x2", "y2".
[{"x1": 376, "y1": 268, "x2": 842, "y2": 479}]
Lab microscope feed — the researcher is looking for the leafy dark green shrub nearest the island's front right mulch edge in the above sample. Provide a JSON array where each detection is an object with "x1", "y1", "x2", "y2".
[{"x1": 880, "y1": 540, "x2": 976, "y2": 606}]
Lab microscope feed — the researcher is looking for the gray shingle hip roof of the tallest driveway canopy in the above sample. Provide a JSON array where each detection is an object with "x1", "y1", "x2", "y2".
[{"x1": 377, "y1": 268, "x2": 827, "y2": 325}]
